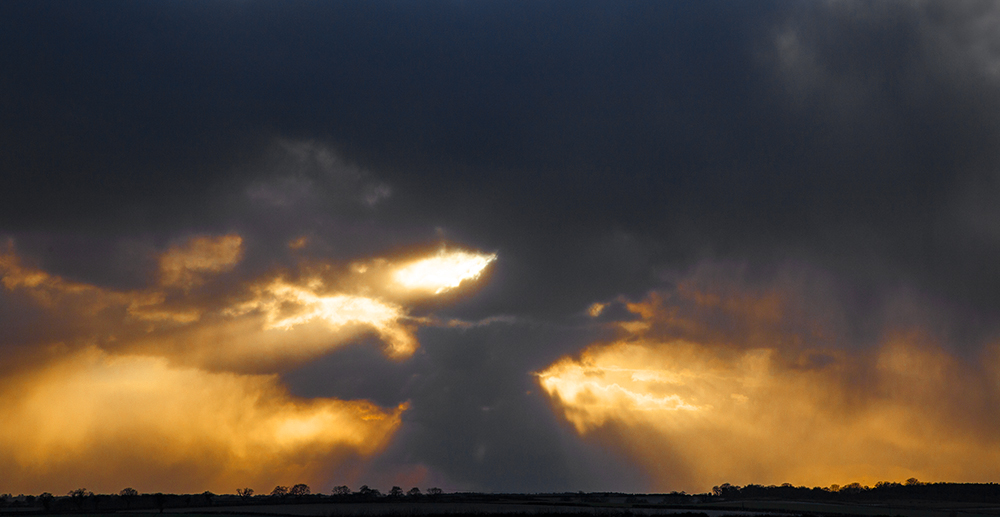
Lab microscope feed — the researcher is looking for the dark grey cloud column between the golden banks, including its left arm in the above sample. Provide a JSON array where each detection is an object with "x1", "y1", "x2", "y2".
[{"x1": 288, "y1": 323, "x2": 648, "y2": 492}]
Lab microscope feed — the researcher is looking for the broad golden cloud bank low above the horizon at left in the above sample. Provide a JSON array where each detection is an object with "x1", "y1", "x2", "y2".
[{"x1": 0, "y1": 349, "x2": 405, "y2": 492}]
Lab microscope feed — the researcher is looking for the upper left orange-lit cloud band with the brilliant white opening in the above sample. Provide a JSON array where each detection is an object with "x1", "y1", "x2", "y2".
[{"x1": 0, "y1": 239, "x2": 495, "y2": 371}]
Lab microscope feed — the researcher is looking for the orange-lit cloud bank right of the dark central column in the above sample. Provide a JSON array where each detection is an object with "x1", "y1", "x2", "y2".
[{"x1": 538, "y1": 284, "x2": 1000, "y2": 491}]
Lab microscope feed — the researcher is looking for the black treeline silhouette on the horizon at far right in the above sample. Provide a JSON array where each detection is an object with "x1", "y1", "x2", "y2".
[{"x1": 712, "y1": 478, "x2": 1000, "y2": 503}]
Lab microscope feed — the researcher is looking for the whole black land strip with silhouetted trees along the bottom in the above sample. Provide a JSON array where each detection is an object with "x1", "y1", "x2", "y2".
[{"x1": 0, "y1": 479, "x2": 1000, "y2": 517}]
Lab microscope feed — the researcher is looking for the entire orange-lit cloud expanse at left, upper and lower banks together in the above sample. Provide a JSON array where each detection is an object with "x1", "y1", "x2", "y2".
[{"x1": 0, "y1": 235, "x2": 492, "y2": 493}]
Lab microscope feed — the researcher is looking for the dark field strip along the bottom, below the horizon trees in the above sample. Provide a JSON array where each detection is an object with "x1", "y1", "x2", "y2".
[{"x1": 9, "y1": 494, "x2": 1000, "y2": 517}]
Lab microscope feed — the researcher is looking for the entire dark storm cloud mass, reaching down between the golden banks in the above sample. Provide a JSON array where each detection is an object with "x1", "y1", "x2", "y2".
[{"x1": 0, "y1": 1, "x2": 1000, "y2": 490}]
